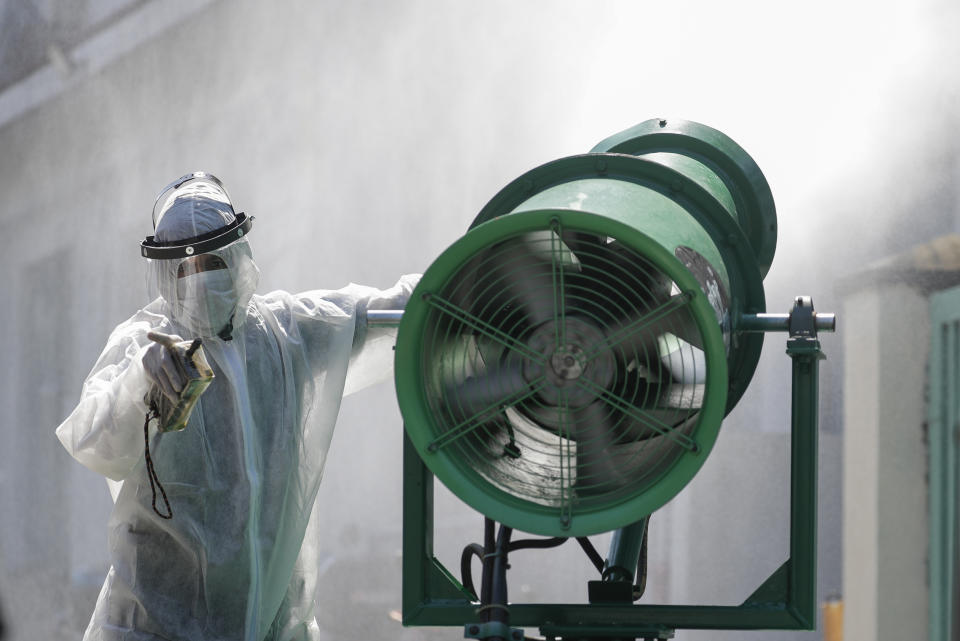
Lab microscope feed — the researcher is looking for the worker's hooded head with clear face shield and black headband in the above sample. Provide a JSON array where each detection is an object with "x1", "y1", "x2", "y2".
[{"x1": 141, "y1": 172, "x2": 260, "y2": 340}]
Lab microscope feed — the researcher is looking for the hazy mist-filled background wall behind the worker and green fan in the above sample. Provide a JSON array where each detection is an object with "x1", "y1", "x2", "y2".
[{"x1": 0, "y1": 0, "x2": 960, "y2": 641}]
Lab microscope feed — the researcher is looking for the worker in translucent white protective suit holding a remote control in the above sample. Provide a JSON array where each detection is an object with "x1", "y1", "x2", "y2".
[{"x1": 57, "y1": 173, "x2": 416, "y2": 641}]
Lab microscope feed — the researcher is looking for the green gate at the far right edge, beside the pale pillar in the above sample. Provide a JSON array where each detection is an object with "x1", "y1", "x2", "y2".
[{"x1": 928, "y1": 287, "x2": 960, "y2": 641}]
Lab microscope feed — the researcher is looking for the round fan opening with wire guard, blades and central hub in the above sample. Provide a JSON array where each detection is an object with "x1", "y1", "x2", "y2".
[{"x1": 401, "y1": 210, "x2": 719, "y2": 534}]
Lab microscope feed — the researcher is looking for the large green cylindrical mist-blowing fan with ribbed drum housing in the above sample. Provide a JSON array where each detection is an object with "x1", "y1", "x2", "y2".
[{"x1": 396, "y1": 120, "x2": 776, "y2": 536}]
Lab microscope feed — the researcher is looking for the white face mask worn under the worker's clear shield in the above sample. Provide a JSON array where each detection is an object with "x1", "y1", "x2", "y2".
[{"x1": 177, "y1": 269, "x2": 238, "y2": 338}]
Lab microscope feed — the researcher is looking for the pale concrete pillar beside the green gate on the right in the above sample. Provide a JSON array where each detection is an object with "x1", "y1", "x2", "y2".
[{"x1": 843, "y1": 283, "x2": 930, "y2": 641}]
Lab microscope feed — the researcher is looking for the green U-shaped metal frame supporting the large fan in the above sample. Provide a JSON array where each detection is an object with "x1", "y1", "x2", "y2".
[{"x1": 403, "y1": 330, "x2": 823, "y2": 638}]
